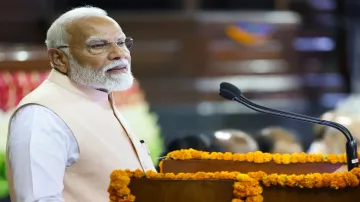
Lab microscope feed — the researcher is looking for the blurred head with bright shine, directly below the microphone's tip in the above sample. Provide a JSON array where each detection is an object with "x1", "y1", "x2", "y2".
[{"x1": 214, "y1": 129, "x2": 258, "y2": 153}]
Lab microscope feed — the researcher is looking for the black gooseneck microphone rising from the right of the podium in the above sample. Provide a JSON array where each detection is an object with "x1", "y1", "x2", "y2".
[{"x1": 219, "y1": 82, "x2": 359, "y2": 171}]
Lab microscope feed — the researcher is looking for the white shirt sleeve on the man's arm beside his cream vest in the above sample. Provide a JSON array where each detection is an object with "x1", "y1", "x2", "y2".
[{"x1": 8, "y1": 105, "x2": 79, "y2": 202}]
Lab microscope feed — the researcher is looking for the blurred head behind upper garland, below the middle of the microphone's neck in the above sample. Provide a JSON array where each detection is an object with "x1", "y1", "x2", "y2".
[{"x1": 255, "y1": 126, "x2": 303, "y2": 154}]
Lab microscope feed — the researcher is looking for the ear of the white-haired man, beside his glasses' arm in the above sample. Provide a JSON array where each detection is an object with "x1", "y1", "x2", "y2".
[{"x1": 47, "y1": 48, "x2": 69, "y2": 74}]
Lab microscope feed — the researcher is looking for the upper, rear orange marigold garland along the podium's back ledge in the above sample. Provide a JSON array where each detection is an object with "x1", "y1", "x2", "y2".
[{"x1": 165, "y1": 149, "x2": 360, "y2": 164}]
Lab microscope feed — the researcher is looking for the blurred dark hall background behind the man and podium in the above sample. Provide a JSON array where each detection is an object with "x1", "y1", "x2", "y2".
[{"x1": 0, "y1": 0, "x2": 360, "y2": 199}]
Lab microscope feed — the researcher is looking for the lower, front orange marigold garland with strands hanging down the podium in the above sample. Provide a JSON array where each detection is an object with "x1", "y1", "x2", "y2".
[{"x1": 108, "y1": 168, "x2": 360, "y2": 202}]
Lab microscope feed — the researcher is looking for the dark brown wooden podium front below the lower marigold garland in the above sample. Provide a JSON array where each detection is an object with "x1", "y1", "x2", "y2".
[{"x1": 129, "y1": 179, "x2": 360, "y2": 202}]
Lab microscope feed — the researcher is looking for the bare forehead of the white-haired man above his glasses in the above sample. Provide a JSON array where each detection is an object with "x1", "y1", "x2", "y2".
[{"x1": 67, "y1": 17, "x2": 125, "y2": 44}]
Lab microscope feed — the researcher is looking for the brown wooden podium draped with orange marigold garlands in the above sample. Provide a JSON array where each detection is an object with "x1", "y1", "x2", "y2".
[{"x1": 108, "y1": 150, "x2": 360, "y2": 202}]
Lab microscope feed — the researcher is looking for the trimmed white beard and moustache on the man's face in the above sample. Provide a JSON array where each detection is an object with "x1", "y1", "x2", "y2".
[{"x1": 68, "y1": 56, "x2": 134, "y2": 92}]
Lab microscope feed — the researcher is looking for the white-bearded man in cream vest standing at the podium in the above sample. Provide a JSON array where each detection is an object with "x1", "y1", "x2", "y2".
[{"x1": 7, "y1": 7, "x2": 155, "y2": 202}]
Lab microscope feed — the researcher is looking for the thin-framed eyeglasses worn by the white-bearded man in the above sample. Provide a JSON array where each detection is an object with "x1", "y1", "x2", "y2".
[{"x1": 57, "y1": 37, "x2": 134, "y2": 55}]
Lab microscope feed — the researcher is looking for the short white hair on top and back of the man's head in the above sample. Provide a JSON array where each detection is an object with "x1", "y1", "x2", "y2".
[{"x1": 45, "y1": 6, "x2": 108, "y2": 49}]
